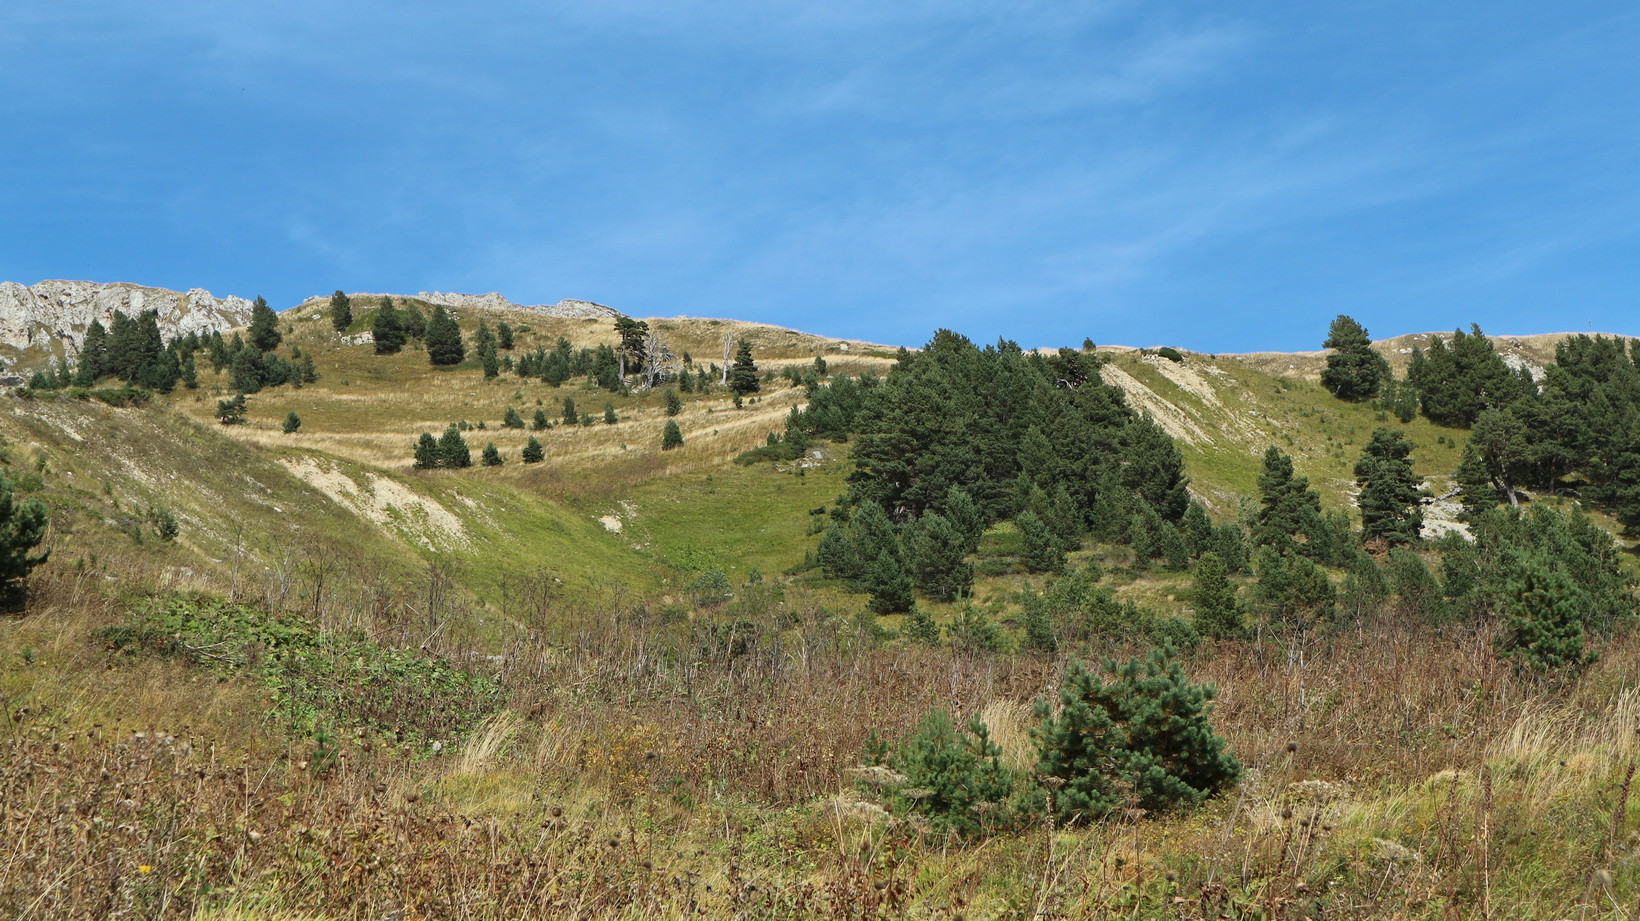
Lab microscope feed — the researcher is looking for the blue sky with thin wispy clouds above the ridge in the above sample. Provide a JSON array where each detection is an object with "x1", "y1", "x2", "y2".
[{"x1": 0, "y1": 0, "x2": 1640, "y2": 351}]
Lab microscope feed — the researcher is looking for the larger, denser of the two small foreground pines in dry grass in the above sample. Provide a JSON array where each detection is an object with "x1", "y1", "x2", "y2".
[{"x1": 1032, "y1": 647, "x2": 1241, "y2": 821}]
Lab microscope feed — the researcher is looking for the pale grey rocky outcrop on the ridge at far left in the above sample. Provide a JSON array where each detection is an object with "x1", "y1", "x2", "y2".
[{"x1": 0, "y1": 280, "x2": 251, "y2": 369}]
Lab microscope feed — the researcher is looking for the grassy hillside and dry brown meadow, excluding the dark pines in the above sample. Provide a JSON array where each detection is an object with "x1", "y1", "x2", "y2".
[{"x1": 0, "y1": 292, "x2": 1640, "y2": 921}]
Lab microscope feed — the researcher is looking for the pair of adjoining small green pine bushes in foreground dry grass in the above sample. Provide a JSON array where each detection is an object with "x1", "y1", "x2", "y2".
[{"x1": 863, "y1": 646, "x2": 1241, "y2": 836}]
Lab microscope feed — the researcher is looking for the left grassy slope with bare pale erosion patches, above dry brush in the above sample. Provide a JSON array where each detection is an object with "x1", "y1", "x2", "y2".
[{"x1": 0, "y1": 386, "x2": 658, "y2": 634}]
